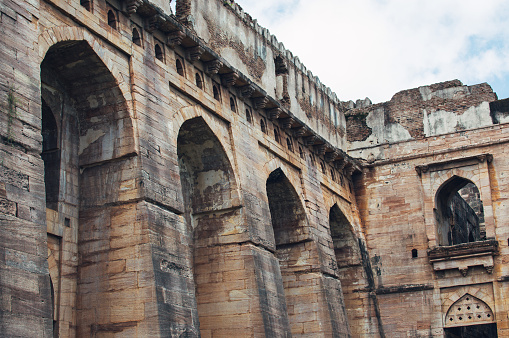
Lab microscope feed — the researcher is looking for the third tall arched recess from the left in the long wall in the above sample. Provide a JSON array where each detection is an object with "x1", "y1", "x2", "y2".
[{"x1": 266, "y1": 168, "x2": 325, "y2": 333}]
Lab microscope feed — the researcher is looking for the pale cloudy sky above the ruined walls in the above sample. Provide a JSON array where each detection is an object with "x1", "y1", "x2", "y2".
[{"x1": 236, "y1": 0, "x2": 509, "y2": 103}]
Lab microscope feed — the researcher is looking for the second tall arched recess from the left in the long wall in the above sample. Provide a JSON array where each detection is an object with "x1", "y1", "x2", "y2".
[{"x1": 177, "y1": 117, "x2": 251, "y2": 337}]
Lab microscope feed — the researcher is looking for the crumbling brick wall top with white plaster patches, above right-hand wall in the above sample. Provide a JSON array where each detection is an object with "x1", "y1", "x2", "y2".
[{"x1": 346, "y1": 80, "x2": 497, "y2": 159}]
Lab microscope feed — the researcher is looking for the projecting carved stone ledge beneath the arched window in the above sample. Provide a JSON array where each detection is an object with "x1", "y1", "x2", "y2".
[{"x1": 428, "y1": 240, "x2": 498, "y2": 276}]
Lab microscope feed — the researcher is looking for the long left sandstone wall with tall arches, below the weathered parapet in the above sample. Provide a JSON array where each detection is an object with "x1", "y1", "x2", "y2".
[{"x1": 0, "y1": 0, "x2": 366, "y2": 337}]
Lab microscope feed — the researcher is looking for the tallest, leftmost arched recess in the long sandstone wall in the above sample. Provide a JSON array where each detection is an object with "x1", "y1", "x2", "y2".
[{"x1": 41, "y1": 39, "x2": 135, "y2": 336}]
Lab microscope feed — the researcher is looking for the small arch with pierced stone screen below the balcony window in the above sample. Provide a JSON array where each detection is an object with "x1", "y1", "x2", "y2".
[{"x1": 444, "y1": 293, "x2": 497, "y2": 338}]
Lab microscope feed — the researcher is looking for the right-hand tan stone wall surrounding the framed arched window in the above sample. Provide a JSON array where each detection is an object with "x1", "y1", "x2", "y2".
[{"x1": 355, "y1": 124, "x2": 509, "y2": 337}]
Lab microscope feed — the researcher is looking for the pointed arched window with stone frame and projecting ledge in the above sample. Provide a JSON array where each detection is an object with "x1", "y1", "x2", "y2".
[{"x1": 415, "y1": 154, "x2": 498, "y2": 276}]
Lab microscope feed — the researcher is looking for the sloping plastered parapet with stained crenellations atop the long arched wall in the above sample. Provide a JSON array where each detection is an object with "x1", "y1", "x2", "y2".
[{"x1": 191, "y1": 0, "x2": 354, "y2": 148}]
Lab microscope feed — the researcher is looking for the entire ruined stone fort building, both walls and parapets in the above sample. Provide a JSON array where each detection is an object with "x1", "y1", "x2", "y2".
[{"x1": 0, "y1": 0, "x2": 508, "y2": 337}]
